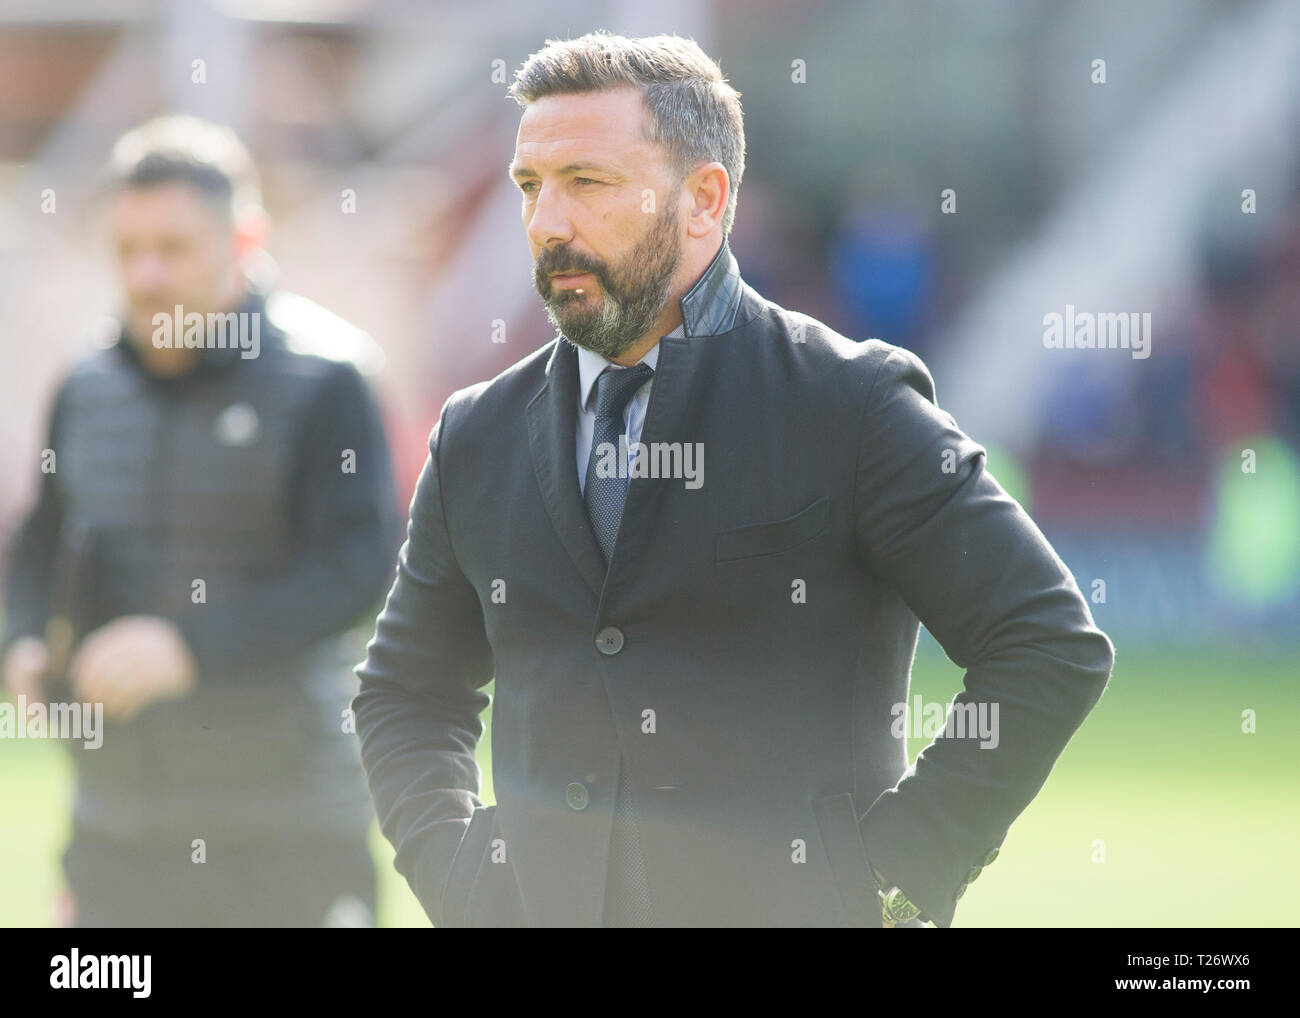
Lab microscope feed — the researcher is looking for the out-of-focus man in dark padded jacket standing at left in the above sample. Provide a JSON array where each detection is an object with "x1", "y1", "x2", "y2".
[{"x1": 3, "y1": 117, "x2": 400, "y2": 927}]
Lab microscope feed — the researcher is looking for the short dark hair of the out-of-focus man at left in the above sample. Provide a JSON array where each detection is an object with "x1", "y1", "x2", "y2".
[{"x1": 105, "y1": 116, "x2": 261, "y2": 221}]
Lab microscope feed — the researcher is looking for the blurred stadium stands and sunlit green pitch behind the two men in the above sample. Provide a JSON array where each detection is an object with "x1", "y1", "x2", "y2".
[{"x1": 0, "y1": 0, "x2": 1300, "y2": 926}]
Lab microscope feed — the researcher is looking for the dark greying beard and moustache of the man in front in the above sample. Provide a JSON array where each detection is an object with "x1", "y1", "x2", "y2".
[{"x1": 533, "y1": 183, "x2": 681, "y2": 360}]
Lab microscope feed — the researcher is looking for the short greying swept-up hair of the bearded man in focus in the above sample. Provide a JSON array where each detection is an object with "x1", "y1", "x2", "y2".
[{"x1": 507, "y1": 30, "x2": 745, "y2": 237}]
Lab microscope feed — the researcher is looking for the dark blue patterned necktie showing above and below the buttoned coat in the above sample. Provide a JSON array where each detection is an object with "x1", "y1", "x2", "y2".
[{"x1": 582, "y1": 364, "x2": 654, "y2": 926}]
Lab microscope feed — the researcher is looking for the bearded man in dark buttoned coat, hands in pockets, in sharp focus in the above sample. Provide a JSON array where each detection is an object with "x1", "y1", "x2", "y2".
[{"x1": 354, "y1": 34, "x2": 1113, "y2": 927}]
